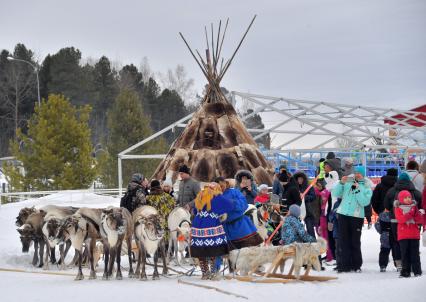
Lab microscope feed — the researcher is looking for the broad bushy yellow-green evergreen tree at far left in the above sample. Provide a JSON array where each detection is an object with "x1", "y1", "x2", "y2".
[{"x1": 5, "y1": 95, "x2": 96, "y2": 190}]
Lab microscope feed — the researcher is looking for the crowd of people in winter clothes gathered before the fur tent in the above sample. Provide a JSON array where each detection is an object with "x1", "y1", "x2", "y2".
[{"x1": 120, "y1": 152, "x2": 426, "y2": 279}]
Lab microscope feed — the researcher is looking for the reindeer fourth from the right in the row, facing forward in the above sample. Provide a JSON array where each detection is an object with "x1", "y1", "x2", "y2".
[{"x1": 58, "y1": 208, "x2": 101, "y2": 280}]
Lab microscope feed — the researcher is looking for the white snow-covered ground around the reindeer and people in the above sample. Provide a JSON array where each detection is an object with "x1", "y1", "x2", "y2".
[{"x1": 0, "y1": 193, "x2": 426, "y2": 302}]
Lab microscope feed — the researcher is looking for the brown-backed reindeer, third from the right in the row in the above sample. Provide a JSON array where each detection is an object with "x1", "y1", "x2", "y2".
[{"x1": 100, "y1": 207, "x2": 134, "y2": 280}]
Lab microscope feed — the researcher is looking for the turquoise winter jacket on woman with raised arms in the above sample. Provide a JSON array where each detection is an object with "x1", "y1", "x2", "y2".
[{"x1": 332, "y1": 180, "x2": 373, "y2": 218}]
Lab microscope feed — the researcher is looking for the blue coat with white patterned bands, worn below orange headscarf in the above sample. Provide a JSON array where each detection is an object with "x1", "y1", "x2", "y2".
[{"x1": 191, "y1": 195, "x2": 233, "y2": 258}]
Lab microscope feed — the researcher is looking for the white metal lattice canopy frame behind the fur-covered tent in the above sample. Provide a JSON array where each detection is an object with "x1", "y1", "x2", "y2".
[{"x1": 118, "y1": 91, "x2": 426, "y2": 195}]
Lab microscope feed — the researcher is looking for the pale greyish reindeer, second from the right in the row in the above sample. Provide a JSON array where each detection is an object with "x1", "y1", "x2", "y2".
[{"x1": 133, "y1": 206, "x2": 167, "y2": 280}]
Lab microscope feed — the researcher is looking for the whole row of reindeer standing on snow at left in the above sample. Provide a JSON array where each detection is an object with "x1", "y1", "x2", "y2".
[{"x1": 16, "y1": 205, "x2": 191, "y2": 280}]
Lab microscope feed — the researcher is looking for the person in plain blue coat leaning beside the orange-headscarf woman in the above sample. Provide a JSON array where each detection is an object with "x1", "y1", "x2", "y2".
[{"x1": 215, "y1": 177, "x2": 263, "y2": 250}]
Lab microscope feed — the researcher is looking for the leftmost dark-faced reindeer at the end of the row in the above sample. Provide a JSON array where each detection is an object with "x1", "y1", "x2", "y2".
[{"x1": 17, "y1": 212, "x2": 45, "y2": 267}]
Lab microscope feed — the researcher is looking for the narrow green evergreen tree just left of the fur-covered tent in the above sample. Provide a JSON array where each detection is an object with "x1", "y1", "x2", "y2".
[{"x1": 101, "y1": 89, "x2": 167, "y2": 186}]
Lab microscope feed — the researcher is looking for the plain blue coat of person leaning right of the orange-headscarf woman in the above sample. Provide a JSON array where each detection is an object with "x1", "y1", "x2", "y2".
[{"x1": 223, "y1": 188, "x2": 257, "y2": 240}]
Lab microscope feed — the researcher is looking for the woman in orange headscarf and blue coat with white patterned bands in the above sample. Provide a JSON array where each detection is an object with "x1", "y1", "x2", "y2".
[{"x1": 190, "y1": 183, "x2": 233, "y2": 280}]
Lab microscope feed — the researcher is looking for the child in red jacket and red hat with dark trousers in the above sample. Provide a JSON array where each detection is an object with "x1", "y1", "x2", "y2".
[{"x1": 394, "y1": 190, "x2": 425, "y2": 278}]
